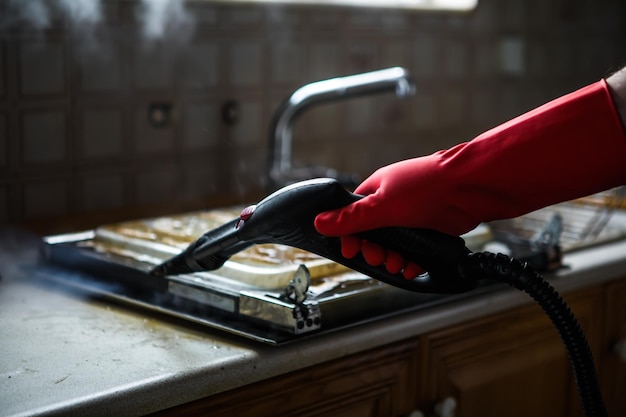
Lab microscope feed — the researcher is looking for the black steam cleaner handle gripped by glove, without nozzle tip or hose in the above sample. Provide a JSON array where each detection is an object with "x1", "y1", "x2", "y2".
[{"x1": 235, "y1": 178, "x2": 474, "y2": 293}]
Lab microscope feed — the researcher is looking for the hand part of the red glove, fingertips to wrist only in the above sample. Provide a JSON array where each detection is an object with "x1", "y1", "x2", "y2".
[{"x1": 315, "y1": 152, "x2": 479, "y2": 279}]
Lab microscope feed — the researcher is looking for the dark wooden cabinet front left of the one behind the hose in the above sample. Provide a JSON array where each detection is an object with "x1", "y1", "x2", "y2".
[{"x1": 148, "y1": 340, "x2": 420, "y2": 417}]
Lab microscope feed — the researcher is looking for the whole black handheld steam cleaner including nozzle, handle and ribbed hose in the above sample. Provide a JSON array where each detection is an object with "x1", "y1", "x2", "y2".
[{"x1": 151, "y1": 178, "x2": 607, "y2": 417}]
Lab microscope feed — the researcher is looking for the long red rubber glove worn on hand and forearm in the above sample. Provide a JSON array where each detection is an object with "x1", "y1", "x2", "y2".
[{"x1": 315, "y1": 80, "x2": 626, "y2": 279}]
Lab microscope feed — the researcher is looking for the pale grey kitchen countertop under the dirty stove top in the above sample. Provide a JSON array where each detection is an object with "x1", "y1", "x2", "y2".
[{"x1": 0, "y1": 223, "x2": 626, "y2": 416}]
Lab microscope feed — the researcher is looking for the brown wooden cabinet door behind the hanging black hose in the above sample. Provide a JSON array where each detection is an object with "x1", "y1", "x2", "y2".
[{"x1": 422, "y1": 290, "x2": 602, "y2": 417}]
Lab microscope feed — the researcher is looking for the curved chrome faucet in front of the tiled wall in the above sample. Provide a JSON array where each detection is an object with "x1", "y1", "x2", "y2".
[{"x1": 268, "y1": 67, "x2": 415, "y2": 190}]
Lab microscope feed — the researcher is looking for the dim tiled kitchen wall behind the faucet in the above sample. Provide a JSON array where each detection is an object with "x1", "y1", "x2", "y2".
[{"x1": 0, "y1": 0, "x2": 626, "y2": 229}]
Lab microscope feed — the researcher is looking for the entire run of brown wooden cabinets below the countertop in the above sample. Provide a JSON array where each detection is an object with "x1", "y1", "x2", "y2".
[{"x1": 150, "y1": 280, "x2": 626, "y2": 417}]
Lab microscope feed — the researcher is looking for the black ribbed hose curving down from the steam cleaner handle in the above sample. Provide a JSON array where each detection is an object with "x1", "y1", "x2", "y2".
[{"x1": 464, "y1": 252, "x2": 607, "y2": 417}]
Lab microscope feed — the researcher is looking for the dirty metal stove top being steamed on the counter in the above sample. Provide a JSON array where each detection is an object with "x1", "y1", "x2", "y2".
[{"x1": 38, "y1": 207, "x2": 486, "y2": 344}]
